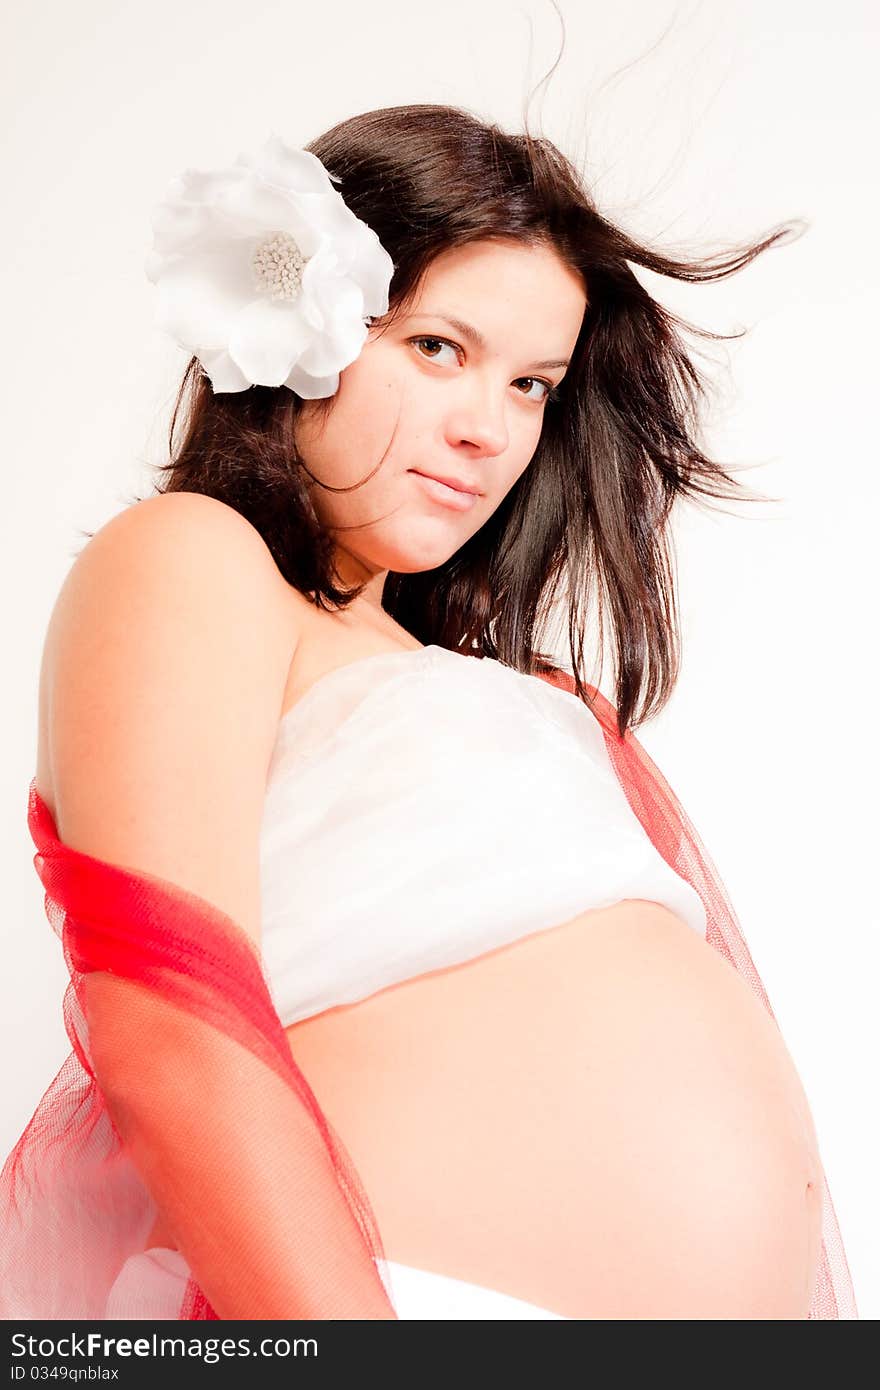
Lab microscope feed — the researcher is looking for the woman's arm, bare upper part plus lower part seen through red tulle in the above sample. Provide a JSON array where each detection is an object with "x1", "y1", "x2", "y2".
[{"x1": 44, "y1": 493, "x2": 393, "y2": 1319}]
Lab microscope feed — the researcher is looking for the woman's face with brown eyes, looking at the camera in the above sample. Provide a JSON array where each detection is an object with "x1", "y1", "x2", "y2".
[{"x1": 296, "y1": 240, "x2": 587, "y2": 602}]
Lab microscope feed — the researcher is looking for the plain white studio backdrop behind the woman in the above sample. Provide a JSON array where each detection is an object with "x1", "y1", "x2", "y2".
[{"x1": 0, "y1": 0, "x2": 880, "y2": 1318}]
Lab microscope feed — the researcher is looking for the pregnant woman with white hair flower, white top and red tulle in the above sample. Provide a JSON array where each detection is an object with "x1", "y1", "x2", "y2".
[{"x1": 0, "y1": 106, "x2": 856, "y2": 1319}]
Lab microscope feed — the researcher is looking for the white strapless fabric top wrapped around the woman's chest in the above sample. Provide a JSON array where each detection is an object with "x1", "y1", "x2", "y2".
[{"x1": 260, "y1": 646, "x2": 706, "y2": 1027}]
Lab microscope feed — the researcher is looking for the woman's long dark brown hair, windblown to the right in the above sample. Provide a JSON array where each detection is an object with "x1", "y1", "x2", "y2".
[{"x1": 140, "y1": 104, "x2": 798, "y2": 734}]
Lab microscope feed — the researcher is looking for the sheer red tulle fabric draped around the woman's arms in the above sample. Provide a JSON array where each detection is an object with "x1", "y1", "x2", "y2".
[{"x1": 0, "y1": 667, "x2": 858, "y2": 1319}]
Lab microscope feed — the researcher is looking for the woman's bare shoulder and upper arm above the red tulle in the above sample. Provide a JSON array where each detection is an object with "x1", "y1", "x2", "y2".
[{"x1": 36, "y1": 493, "x2": 303, "y2": 937}]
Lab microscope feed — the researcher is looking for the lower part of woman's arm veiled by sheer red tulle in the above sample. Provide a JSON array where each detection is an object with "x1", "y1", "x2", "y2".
[{"x1": 89, "y1": 973, "x2": 393, "y2": 1319}]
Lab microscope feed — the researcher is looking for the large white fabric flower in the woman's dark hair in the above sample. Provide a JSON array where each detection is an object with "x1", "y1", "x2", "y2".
[{"x1": 145, "y1": 135, "x2": 393, "y2": 400}]
